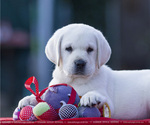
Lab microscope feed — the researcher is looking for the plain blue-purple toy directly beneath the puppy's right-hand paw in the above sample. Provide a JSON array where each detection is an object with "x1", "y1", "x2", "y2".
[{"x1": 78, "y1": 106, "x2": 101, "y2": 117}]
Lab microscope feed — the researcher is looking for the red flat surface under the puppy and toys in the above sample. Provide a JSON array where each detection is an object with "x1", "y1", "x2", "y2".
[{"x1": 0, "y1": 117, "x2": 150, "y2": 125}]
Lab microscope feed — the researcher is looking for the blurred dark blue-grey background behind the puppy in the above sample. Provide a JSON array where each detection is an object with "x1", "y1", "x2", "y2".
[{"x1": 0, "y1": 0, "x2": 150, "y2": 117}]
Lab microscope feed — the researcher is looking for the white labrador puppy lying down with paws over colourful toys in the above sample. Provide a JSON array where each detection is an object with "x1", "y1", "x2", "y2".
[{"x1": 19, "y1": 24, "x2": 150, "y2": 119}]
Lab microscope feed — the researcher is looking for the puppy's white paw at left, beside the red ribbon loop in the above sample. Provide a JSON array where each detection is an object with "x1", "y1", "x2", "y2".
[{"x1": 18, "y1": 95, "x2": 38, "y2": 109}]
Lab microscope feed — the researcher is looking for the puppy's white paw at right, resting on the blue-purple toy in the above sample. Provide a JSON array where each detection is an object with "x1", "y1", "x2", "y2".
[{"x1": 80, "y1": 92, "x2": 106, "y2": 108}]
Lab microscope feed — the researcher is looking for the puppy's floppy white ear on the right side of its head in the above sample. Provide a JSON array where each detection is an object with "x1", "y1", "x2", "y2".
[{"x1": 96, "y1": 30, "x2": 111, "y2": 68}]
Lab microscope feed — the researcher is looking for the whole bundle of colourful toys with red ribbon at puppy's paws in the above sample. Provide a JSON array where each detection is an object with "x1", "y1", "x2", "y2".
[{"x1": 13, "y1": 76, "x2": 110, "y2": 121}]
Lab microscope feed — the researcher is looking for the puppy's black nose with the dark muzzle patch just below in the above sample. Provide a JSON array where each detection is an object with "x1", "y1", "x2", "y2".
[{"x1": 74, "y1": 59, "x2": 86, "y2": 75}]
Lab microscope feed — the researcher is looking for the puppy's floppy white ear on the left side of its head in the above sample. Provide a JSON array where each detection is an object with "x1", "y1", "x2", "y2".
[{"x1": 45, "y1": 30, "x2": 62, "y2": 66}]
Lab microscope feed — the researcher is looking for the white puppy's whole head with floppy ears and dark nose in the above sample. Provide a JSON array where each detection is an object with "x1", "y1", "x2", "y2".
[{"x1": 45, "y1": 24, "x2": 111, "y2": 77}]
